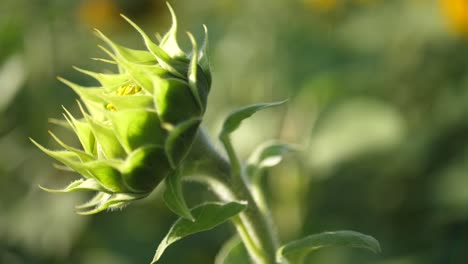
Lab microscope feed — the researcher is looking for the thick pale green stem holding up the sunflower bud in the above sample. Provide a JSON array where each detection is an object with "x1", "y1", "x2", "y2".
[{"x1": 184, "y1": 131, "x2": 278, "y2": 264}]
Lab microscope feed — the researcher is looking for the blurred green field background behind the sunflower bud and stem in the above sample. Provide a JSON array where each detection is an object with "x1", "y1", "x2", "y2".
[{"x1": 0, "y1": 0, "x2": 468, "y2": 264}]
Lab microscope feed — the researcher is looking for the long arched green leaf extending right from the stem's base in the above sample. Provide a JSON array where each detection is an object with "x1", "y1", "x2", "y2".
[{"x1": 276, "y1": 230, "x2": 380, "y2": 262}]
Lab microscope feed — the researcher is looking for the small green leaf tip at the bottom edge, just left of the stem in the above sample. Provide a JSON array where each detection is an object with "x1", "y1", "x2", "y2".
[{"x1": 214, "y1": 236, "x2": 251, "y2": 264}]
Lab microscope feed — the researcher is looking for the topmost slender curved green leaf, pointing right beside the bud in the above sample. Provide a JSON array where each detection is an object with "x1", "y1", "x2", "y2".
[{"x1": 220, "y1": 100, "x2": 286, "y2": 138}]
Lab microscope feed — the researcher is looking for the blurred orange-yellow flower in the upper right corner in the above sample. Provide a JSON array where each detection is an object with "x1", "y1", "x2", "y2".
[{"x1": 440, "y1": 0, "x2": 468, "y2": 36}]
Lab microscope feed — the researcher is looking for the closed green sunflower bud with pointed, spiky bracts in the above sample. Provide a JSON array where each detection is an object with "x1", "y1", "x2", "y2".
[{"x1": 33, "y1": 6, "x2": 211, "y2": 214}]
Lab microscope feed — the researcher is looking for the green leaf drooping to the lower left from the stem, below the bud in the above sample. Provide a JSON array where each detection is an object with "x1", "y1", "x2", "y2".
[{"x1": 151, "y1": 202, "x2": 247, "y2": 264}]
